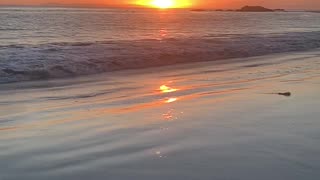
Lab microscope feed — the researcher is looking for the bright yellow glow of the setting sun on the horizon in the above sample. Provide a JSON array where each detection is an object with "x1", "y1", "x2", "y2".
[{"x1": 135, "y1": 0, "x2": 191, "y2": 9}]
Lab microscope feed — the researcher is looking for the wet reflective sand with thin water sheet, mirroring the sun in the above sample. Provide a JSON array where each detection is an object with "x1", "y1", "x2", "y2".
[{"x1": 0, "y1": 51, "x2": 320, "y2": 180}]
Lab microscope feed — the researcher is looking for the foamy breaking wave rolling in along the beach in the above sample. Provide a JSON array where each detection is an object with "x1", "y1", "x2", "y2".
[{"x1": 0, "y1": 32, "x2": 320, "y2": 83}]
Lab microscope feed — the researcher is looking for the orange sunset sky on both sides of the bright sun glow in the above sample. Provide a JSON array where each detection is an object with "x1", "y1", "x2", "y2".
[{"x1": 0, "y1": 0, "x2": 320, "y2": 9}]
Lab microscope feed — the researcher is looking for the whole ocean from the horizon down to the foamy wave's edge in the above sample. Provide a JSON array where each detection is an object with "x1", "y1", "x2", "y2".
[{"x1": 0, "y1": 7, "x2": 320, "y2": 83}]
